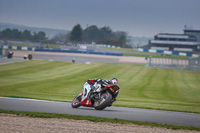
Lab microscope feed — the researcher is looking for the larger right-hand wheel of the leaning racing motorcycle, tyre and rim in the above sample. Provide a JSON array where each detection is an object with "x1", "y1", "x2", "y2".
[{"x1": 94, "y1": 92, "x2": 112, "y2": 110}]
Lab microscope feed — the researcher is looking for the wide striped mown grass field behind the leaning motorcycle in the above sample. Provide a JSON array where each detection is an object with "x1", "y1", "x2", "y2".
[{"x1": 0, "y1": 60, "x2": 200, "y2": 113}]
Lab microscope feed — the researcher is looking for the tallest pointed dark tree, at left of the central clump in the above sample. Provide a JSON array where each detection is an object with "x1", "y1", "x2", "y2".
[{"x1": 69, "y1": 24, "x2": 83, "y2": 43}]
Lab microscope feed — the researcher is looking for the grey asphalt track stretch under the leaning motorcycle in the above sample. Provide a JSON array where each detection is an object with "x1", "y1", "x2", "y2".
[{"x1": 0, "y1": 97, "x2": 200, "y2": 127}]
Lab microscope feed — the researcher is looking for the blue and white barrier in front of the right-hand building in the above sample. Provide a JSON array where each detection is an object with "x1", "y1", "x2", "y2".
[{"x1": 137, "y1": 48, "x2": 200, "y2": 57}]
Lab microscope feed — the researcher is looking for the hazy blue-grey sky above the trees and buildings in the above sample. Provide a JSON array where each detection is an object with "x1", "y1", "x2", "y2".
[{"x1": 0, "y1": 0, "x2": 200, "y2": 37}]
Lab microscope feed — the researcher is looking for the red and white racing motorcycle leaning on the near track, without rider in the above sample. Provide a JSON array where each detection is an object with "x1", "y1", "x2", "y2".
[{"x1": 71, "y1": 82, "x2": 120, "y2": 110}]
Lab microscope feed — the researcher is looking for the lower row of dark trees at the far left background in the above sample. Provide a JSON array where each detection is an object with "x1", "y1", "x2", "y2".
[{"x1": 0, "y1": 28, "x2": 47, "y2": 42}]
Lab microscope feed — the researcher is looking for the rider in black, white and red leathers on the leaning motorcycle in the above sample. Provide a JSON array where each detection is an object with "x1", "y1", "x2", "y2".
[{"x1": 87, "y1": 78, "x2": 119, "y2": 106}]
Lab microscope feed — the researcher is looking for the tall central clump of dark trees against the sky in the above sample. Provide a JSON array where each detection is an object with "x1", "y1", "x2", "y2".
[{"x1": 67, "y1": 24, "x2": 128, "y2": 47}]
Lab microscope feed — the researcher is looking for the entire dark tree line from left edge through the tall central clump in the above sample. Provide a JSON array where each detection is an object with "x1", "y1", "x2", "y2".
[{"x1": 0, "y1": 24, "x2": 129, "y2": 47}]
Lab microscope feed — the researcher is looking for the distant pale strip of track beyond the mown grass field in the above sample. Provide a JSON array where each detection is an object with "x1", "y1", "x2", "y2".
[{"x1": 13, "y1": 50, "x2": 146, "y2": 64}]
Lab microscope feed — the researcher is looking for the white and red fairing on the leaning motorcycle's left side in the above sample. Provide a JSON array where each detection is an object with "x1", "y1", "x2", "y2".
[{"x1": 80, "y1": 82, "x2": 93, "y2": 107}]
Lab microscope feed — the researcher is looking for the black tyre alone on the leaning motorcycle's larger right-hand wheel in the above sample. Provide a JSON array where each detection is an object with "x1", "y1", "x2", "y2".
[{"x1": 94, "y1": 92, "x2": 112, "y2": 110}]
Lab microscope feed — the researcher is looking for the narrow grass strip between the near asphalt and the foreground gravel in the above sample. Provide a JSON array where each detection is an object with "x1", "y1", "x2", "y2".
[{"x1": 0, "y1": 110, "x2": 200, "y2": 131}]
